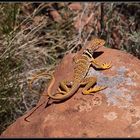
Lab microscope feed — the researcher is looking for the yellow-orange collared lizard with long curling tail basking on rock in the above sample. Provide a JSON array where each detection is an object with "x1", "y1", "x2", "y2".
[{"x1": 25, "y1": 38, "x2": 111, "y2": 121}]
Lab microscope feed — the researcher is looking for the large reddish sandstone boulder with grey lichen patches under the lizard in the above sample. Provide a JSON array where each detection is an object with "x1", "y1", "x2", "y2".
[{"x1": 1, "y1": 47, "x2": 140, "y2": 137}]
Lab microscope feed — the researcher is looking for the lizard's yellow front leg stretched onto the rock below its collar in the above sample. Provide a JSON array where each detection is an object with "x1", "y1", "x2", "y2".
[{"x1": 91, "y1": 58, "x2": 111, "y2": 69}]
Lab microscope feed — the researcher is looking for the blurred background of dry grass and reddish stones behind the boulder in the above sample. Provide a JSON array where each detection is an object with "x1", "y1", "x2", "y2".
[{"x1": 0, "y1": 2, "x2": 140, "y2": 133}]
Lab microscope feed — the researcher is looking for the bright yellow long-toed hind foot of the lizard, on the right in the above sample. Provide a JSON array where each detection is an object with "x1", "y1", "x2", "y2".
[{"x1": 83, "y1": 86, "x2": 107, "y2": 95}]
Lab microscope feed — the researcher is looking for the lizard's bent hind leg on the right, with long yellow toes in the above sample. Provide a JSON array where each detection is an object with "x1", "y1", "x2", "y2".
[{"x1": 81, "y1": 77, "x2": 107, "y2": 95}]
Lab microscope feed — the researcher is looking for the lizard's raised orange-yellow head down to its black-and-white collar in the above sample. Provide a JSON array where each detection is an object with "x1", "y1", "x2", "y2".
[{"x1": 84, "y1": 38, "x2": 105, "y2": 57}]
